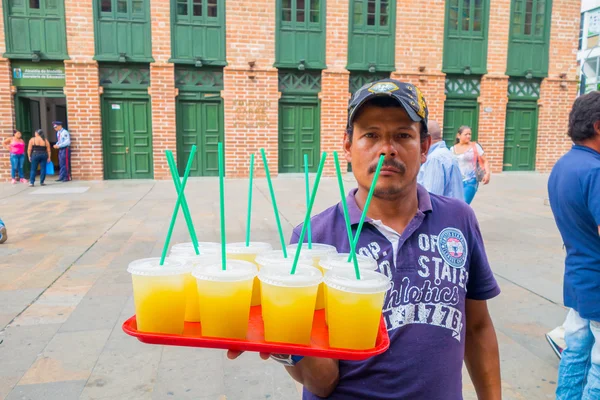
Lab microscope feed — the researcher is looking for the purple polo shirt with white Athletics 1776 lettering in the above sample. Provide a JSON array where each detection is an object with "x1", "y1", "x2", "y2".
[{"x1": 291, "y1": 186, "x2": 500, "y2": 400}]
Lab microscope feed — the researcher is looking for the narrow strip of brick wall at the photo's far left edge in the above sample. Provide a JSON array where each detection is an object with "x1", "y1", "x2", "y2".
[{"x1": 0, "y1": 2, "x2": 15, "y2": 183}]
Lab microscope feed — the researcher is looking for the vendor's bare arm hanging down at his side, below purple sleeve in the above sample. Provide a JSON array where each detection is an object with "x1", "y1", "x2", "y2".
[{"x1": 465, "y1": 299, "x2": 502, "y2": 400}]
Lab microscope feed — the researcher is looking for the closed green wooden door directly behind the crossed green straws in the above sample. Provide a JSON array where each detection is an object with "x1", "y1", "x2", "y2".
[{"x1": 177, "y1": 101, "x2": 224, "y2": 176}]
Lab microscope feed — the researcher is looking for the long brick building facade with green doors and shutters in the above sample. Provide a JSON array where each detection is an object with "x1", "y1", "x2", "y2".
[{"x1": 0, "y1": 0, "x2": 580, "y2": 180}]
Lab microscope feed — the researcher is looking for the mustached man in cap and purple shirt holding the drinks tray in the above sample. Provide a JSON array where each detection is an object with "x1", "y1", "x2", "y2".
[{"x1": 229, "y1": 79, "x2": 501, "y2": 400}]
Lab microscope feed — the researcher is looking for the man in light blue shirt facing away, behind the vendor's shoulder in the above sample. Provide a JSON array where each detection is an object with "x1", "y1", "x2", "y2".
[{"x1": 417, "y1": 121, "x2": 465, "y2": 200}]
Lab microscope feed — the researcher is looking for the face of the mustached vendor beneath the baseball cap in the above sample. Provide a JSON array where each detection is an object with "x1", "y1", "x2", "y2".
[{"x1": 344, "y1": 105, "x2": 431, "y2": 199}]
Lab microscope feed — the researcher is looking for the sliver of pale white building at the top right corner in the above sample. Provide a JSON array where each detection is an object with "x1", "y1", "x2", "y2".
[{"x1": 577, "y1": 0, "x2": 600, "y2": 94}]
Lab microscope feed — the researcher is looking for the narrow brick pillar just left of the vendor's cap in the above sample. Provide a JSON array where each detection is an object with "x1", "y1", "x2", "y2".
[{"x1": 319, "y1": 0, "x2": 350, "y2": 176}]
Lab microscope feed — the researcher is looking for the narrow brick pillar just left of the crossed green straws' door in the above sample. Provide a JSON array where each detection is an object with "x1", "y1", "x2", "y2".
[{"x1": 148, "y1": 0, "x2": 177, "y2": 179}]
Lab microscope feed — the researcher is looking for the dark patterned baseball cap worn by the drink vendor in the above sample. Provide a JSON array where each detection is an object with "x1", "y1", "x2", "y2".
[{"x1": 348, "y1": 79, "x2": 429, "y2": 132}]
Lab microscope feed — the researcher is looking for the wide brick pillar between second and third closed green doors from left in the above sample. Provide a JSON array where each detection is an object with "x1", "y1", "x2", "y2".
[{"x1": 222, "y1": 0, "x2": 280, "y2": 177}]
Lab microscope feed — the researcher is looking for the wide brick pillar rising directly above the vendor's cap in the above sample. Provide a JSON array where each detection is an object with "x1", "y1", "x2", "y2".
[{"x1": 392, "y1": 0, "x2": 446, "y2": 122}]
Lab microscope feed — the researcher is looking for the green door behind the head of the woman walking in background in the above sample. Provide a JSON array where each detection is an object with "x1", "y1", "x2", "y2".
[{"x1": 443, "y1": 100, "x2": 479, "y2": 147}]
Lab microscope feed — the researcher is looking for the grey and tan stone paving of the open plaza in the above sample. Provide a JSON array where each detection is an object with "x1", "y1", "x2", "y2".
[{"x1": 0, "y1": 174, "x2": 566, "y2": 400}]
